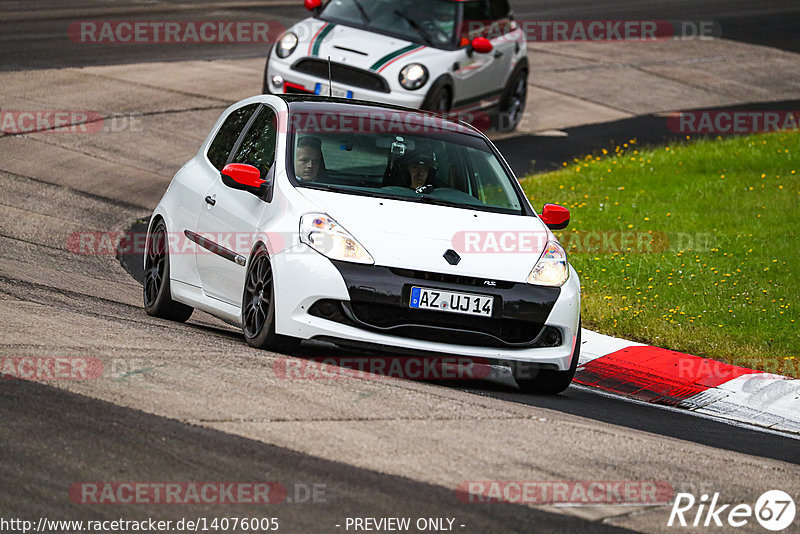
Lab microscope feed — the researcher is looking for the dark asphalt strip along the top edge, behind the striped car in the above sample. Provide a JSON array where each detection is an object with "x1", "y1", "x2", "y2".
[{"x1": 0, "y1": 0, "x2": 800, "y2": 69}]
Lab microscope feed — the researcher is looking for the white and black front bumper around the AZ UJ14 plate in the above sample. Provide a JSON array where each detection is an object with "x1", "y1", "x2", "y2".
[{"x1": 272, "y1": 245, "x2": 580, "y2": 370}]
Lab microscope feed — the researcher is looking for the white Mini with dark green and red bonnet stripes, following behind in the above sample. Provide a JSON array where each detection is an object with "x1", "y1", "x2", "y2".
[{"x1": 263, "y1": 0, "x2": 528, "y2": 131}]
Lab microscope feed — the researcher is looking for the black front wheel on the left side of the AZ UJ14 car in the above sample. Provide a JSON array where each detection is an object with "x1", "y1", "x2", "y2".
[{"x1": 242, "y1": 247, "x2": 300, "y2": 352}]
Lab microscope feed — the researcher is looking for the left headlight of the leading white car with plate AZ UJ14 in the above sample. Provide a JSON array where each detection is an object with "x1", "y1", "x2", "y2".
[{"x1": 300, "y1": 213, "x2": 375, "y2": 264}]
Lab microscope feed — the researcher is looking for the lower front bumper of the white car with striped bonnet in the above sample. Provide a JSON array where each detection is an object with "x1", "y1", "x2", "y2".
[{"x1": 264, "y1": 56, "x2": 425, "y2": 108}]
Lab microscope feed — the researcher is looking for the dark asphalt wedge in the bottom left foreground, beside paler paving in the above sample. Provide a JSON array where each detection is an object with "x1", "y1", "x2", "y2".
[{"x1": 0, "y1": 381, "x2": 629, "y2": 533}]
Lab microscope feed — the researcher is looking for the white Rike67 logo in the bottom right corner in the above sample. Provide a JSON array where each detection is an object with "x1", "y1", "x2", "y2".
[{"x1": 667, "y1": 490, "x2": 796, "y2": 532}]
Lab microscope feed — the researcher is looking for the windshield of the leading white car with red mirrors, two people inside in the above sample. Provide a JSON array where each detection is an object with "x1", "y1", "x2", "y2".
[{"x1": 289, "y1": 106, "x2": 524, "y2": 214}]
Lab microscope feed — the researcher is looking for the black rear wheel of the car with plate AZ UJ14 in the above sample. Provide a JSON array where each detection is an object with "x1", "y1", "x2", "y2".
[{"x1": 142, "y1": 221, "x2": 194, "y2": 323}]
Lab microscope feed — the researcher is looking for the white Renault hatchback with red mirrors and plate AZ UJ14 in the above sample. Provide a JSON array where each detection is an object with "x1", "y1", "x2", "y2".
[{"x1": 144, "y1": 95, "x2": 580, "y2": 392}]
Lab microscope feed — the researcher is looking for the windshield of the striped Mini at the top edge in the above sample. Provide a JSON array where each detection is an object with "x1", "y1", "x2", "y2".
[{"x1": 321, "y1": 0, "x2": 458, "y2": 47}]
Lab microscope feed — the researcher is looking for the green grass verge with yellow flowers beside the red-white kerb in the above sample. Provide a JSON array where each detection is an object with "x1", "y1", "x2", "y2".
[{"x1": 522, "y1": 132, "x2": 800, "y2": 377}]
